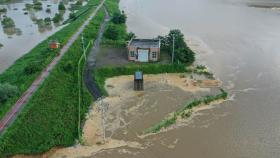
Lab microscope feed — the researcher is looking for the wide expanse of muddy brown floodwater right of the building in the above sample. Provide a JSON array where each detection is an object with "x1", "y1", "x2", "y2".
[{"x1": 91, "y1": 0, "x2": 280, "y2": 158}]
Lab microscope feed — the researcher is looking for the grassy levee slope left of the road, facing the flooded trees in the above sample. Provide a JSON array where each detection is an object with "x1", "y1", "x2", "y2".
[{"x1": 0, "y1": 0, "x2": 101, "y2": 118}]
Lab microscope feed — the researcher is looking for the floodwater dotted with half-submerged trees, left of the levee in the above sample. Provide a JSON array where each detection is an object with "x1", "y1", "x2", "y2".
[{"x1": 0, "y1": 0, "x2": 73, "y2": 73}]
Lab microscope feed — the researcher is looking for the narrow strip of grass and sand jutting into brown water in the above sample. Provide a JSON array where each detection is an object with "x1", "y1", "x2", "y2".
[{"x1": 144, "y1": 89, "x2": 228, "y2": 134}]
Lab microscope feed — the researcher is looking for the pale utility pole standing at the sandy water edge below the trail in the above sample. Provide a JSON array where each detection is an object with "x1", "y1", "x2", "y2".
[{"x1": 98, "y1": 97, "x2": 109, "y2": 143}]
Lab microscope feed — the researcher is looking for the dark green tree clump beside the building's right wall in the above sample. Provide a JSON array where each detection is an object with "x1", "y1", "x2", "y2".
[{"x1": 158, "y1": 29, "x2": 195, "y2": 64}]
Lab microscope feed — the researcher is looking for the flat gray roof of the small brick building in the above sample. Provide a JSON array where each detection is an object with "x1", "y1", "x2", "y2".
[{"x1": 129, "y1": 39, "x2": 160, "y2": 48}]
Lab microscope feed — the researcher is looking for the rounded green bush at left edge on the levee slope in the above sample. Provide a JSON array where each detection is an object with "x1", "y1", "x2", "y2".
[{"x1": 0, "y1": 83, "x2": 18, "y2": 104}]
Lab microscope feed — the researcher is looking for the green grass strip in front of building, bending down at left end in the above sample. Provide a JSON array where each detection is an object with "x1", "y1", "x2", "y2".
[{"x1": 92, "y1": 64, "x2": 189, "y2": 95}]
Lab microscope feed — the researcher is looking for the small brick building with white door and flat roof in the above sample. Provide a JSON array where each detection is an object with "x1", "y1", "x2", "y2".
[{"x1": 128, "y1": 39, "x2": 160, "y2": 62}]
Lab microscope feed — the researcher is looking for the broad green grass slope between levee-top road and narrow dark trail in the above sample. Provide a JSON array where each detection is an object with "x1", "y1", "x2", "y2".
[{"x1": 0, "y1": 4, "x2": 105, "y2": 156}]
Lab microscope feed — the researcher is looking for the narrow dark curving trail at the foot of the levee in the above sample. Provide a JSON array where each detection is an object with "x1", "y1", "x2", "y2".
[{"x1": 84, "y1": 7, "x2": 111, "y2": 99}]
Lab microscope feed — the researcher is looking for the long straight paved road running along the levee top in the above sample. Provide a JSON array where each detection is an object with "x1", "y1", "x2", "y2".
[{"x1": 0, "y1": 0, "x2": 105, "y2": 133}]
